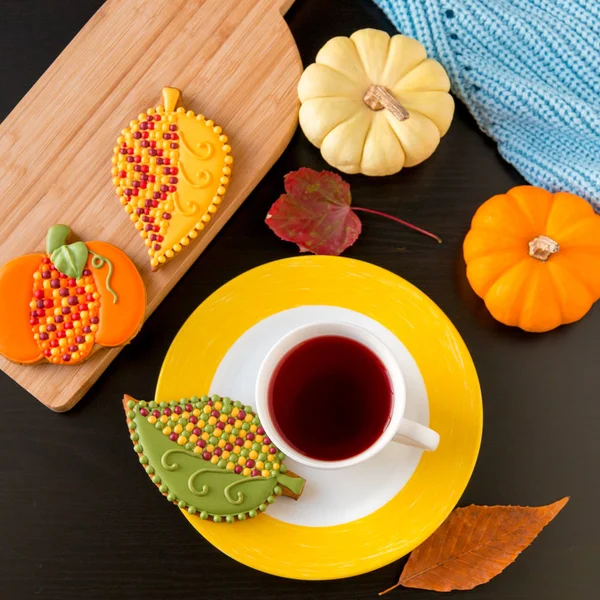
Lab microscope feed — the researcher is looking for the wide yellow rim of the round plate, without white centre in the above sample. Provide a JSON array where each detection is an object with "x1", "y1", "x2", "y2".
[{"x1": 156, "y1": 256, "x2": 483, "y2": 579}]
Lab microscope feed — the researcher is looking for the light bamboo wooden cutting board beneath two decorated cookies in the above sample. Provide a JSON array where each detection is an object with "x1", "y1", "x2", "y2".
[{"x1": 0, "y1": 0, "x2": 302, "y2": 411}]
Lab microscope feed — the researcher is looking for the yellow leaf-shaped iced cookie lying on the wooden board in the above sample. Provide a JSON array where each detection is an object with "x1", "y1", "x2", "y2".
[{"x1": 112, "y1": 88, "x2": 233, "y2": 270}]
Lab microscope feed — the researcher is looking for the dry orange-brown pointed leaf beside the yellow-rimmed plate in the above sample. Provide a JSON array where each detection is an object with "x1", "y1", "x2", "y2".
[{"x1": 379, "y1": 497, "x2": 569, "y2": 596}]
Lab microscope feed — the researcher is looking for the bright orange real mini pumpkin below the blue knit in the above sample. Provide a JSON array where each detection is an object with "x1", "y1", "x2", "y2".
[{"x1": 463, "y1": 185, "x2": 600, "y2": 332}]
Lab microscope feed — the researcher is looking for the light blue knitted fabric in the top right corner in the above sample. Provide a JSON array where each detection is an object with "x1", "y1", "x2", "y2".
[{"x1": 374, "y1": 0, "x2": 600, "y2": 211}]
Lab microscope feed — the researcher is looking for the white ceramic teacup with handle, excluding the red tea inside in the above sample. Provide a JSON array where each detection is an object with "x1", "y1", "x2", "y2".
[{"x1": 255, "y1": 322, "x2": 440, "y2": 469}]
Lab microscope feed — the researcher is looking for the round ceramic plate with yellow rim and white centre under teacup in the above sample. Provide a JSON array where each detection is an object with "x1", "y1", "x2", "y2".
[{"x1": 156, "y1": 257, "x2": 482, "y2": 579}]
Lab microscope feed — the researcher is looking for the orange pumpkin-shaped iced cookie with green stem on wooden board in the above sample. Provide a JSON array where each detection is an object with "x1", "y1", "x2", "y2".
[{"x1": 0, "y1": 225, "x2": 146, "y2": 365}]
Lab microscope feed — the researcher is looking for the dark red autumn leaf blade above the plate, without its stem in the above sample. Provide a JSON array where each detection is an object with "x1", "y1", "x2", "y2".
[{"x1": 266, "y1": 168, "x2": 362, "y2": 256}]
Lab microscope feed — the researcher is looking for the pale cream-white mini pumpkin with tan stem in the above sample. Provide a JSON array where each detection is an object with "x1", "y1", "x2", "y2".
[{"x1": 298, "y1": 29, "x2": 454, "y2": 175}]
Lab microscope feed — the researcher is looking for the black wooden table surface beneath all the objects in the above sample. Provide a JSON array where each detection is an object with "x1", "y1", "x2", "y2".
[{"x1": 0, "y1": 0, "x2": 600, "y2": 600}]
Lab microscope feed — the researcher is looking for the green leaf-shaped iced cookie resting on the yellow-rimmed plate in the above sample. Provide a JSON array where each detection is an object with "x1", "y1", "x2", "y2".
[{"x1": 123, "y1": 395, "x2": 304, "y2": 523}]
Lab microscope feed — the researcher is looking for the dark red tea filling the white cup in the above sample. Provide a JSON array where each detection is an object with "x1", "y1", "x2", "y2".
[{"x1": 268, "y1": 335, "x2": 394, "y2": 461}]
